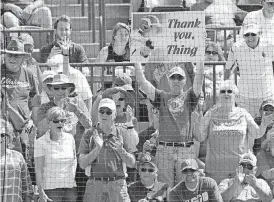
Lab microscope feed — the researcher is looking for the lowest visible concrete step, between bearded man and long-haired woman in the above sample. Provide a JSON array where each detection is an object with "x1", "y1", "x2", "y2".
[{"x1": 71, "y1": 30, "x2": 112, "y2": 43}]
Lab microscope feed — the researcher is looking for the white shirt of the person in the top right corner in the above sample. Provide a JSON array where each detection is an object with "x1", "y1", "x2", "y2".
[{"x1": 241, "y1": 9, "x2": 274, "y2": 43}]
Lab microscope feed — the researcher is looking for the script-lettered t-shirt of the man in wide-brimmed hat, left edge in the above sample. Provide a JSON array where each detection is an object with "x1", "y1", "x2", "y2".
[{"x1": 1, "y1": 64, "x2": 38, "y2": 119}]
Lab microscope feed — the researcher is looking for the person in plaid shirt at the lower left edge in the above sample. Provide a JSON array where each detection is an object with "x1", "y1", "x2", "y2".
[{"x1": 0, "y1": 118, "x2": 33, "y2": 202}]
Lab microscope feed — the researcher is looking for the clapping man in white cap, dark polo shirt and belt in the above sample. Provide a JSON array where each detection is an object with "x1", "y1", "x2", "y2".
[{"x1": 79, "y1": 98, "x2": 136, "y2": 202}]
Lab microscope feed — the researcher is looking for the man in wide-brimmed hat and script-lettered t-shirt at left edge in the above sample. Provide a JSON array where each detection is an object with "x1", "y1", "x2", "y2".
[{"x1": 1, "y1": 38, "x2": 38, "y2": 161}]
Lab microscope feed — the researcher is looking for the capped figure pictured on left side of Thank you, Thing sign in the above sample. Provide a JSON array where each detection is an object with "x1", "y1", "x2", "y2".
[{"x1": 130, "y1": 15, "x2": 163, "y2": 62}]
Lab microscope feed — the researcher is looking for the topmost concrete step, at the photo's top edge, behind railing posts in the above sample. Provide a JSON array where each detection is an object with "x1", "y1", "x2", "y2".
[{"x1": 48, "y1": 4, "x2": 130, "y2": 18}]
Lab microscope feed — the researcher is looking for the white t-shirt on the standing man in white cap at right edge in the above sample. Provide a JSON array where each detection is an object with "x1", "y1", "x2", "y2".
[{"x1": 226, "y1": 40, "x2": 274, "y2": 99}]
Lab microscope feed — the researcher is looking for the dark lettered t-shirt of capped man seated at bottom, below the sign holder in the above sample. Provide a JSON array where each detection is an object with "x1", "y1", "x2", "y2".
[{"x1": 169, "y1": 177, "x2": 223, "y2": 202}]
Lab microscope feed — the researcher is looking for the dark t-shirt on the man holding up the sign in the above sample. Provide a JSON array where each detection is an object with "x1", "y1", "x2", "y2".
[{"x1": 152, "y1": 88, "x2": 198, "y2": 142}]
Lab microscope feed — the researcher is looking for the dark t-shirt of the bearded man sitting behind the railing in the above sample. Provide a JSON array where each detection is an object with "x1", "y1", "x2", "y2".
[{"x1": 40, "y1": 41, "x2": 88, "y2": 63}]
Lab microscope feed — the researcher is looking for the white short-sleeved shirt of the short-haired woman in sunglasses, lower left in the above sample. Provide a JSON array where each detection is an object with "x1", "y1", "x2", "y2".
[{"x1": 34, "y1": 131, "x2": 77, "y2": 190}]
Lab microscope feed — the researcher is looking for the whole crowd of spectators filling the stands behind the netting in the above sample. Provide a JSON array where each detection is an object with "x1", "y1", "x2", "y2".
[{"x1": 0, "y1": 0, "x2": 274, "y2": 202}]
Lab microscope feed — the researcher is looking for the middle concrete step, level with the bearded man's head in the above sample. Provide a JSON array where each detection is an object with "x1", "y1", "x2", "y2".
[{"x1": 52, "y1": 17, "x2": 128, "y2": 31}]
